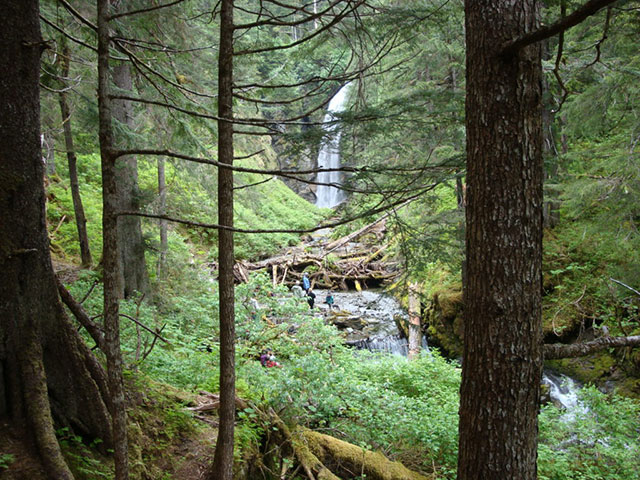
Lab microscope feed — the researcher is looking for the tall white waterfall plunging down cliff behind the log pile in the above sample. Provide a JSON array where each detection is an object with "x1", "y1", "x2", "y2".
[{"x1": 316, "y1": 83, "x2": 350, "y2": 208}]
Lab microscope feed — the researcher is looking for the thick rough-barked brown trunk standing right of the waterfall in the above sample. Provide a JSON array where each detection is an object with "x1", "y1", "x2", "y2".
[{"x1": 458, "y1": 0, "x2": 542, "y2": 480}]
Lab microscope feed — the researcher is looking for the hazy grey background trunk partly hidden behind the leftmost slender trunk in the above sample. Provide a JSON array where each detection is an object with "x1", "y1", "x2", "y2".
[{"x1": 112, "y1": 64, "x2": 150, "y2": 298}]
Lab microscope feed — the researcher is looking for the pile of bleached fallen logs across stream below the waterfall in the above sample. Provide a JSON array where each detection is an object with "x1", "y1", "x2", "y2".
[{"x1": 234, "y1": 217, "x2": 398, "y2": 290}]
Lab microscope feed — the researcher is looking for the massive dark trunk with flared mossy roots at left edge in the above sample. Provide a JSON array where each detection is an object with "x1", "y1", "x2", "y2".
[{"x1": 0, "y1": 0, "x2": 112, "y2": 479}]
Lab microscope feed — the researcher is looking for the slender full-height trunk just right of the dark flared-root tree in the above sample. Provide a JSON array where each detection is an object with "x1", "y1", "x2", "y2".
[{"x1": 98, "y1": 0, "x2": 129, "y2": 480}]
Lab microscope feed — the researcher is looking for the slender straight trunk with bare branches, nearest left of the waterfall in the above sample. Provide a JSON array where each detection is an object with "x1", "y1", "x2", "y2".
[{"x1": 209, "y1": 0, "x2": 235, "y2": 480}]
